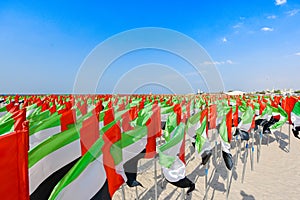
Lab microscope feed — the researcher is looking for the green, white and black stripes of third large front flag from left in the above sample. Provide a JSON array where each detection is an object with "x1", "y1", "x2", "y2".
[{"x1": 49, "y1": 138, "x2": 111, "y2": 200}]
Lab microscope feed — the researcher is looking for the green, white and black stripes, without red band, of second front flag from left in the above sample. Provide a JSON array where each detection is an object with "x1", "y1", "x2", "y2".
[{"x1": 28, "y1": 127, "x2": 81, "y2": 199}]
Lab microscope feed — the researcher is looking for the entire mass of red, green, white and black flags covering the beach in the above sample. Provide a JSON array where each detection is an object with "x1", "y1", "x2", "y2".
[{"x1": 0, "y1": 95, "x2": 300, "y2": 199}]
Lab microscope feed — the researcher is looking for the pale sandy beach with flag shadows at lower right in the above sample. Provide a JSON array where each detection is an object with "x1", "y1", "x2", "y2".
[{"x1": 113, "y1": 124, "x2": 300, "y2": 200}]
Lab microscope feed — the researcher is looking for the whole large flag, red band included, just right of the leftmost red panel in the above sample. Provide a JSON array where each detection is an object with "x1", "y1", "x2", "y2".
[{"x1": 28, "y1": 110, "x2": 99, "y2": 199}]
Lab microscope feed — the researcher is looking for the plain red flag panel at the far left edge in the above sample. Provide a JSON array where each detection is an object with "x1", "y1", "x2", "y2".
[{"x1": 0, "y1": 122, "x2": 29, "y2": 200}]
